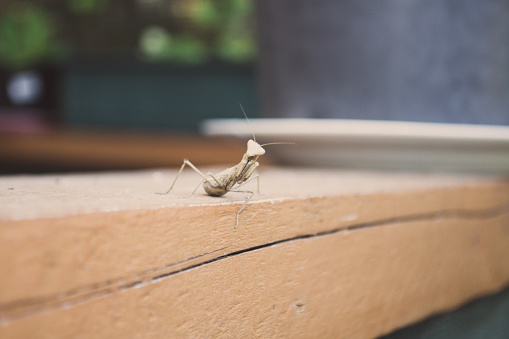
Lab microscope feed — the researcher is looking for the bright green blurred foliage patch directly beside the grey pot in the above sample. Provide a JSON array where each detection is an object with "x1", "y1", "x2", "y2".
[{"x1": 140, "y1": 0, "x2": 256, "y2": 64}]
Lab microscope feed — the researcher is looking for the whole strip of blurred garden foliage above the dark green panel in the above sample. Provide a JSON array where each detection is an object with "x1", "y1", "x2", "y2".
[{"x1": 0, "y1": 0, "x2": 257, "y2": 71}]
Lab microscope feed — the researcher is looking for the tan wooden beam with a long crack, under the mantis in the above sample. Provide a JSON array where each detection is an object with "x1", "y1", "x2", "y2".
[{"x1": 0, "y1": 168, "x2": 509, "y2": 338}]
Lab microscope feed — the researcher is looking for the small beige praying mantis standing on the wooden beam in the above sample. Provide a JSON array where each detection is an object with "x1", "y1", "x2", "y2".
[{"x1": 158, "y1": 105, "x2": 294, "y2": 228}]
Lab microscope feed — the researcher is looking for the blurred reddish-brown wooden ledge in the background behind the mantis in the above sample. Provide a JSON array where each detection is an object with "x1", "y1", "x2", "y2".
[{"x1": 0, "y1": 129, "x2": 246, "y2": 174}]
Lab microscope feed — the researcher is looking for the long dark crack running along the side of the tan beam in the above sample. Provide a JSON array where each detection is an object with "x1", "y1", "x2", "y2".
[{"x1": 0, "y1": 202, "x2": 509, "y2": 326}]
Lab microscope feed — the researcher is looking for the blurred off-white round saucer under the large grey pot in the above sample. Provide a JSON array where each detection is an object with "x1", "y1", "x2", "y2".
[{"x1": 202, "y1": 119, "x2": 509, "y2": 174}]
